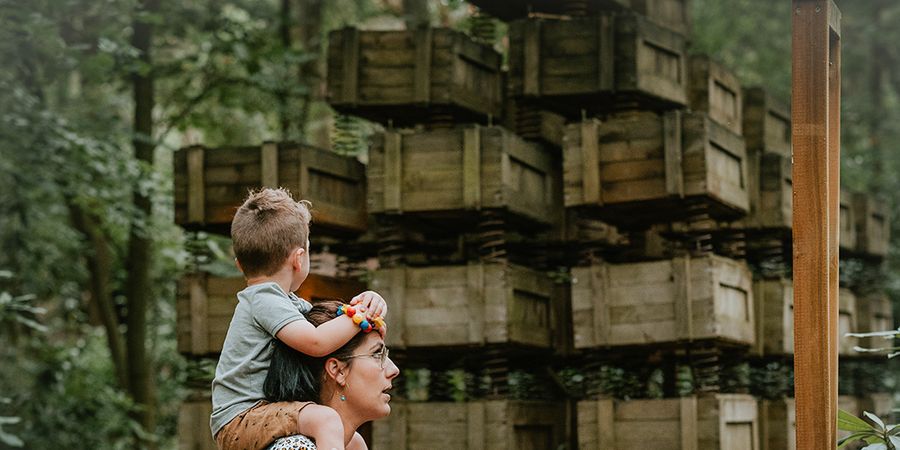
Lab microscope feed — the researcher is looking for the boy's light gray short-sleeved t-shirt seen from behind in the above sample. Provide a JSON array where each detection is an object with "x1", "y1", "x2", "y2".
[{"x1": 209, "y1": 283, "x2": 312, "y2": 437}]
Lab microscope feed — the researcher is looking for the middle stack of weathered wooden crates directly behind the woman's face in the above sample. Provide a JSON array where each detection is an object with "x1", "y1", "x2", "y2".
[{"x1": 328, "y1": 20, "x2": 565, "y2": 449}]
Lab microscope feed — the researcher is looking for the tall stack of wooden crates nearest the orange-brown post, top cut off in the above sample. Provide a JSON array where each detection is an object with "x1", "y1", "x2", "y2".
[{"x1": 464, "y1": 0, "x2": 768, "y2": 449}]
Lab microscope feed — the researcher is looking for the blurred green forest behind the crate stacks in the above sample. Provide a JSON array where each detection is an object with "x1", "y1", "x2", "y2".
[{"x1": 0, "y1": 0, "x2": 900, "y2": 449}]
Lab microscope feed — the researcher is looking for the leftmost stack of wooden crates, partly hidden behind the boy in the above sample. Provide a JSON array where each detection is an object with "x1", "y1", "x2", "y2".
[{"x1": 174, "y1": 142, "x2": 368, "y2": 449}]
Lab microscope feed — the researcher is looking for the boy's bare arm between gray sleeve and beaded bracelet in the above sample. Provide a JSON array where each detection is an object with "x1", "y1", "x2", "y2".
[{"x1": 275, "y1": 314, "x2": 360, "y2": 358}]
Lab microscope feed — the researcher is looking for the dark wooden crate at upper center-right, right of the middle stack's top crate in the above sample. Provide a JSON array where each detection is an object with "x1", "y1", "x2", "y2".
[{"x1": 509, "y1": 14, "x2": 687, "y2": 118}]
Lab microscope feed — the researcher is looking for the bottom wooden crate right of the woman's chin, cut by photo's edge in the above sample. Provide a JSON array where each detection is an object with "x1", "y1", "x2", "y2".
[{"x1": 371, "y1": 400, "x2": 566, "y2": 450}]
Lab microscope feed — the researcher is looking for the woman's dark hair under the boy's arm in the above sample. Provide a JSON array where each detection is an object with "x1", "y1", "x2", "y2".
[{"x1": 263, "y1": 300, "x2": 365, "y2": 403}]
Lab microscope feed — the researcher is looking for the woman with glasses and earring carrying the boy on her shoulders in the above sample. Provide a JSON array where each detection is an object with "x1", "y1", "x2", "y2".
[{"x1": 263, "y1": 301, "x2": 400, "y2": 450}]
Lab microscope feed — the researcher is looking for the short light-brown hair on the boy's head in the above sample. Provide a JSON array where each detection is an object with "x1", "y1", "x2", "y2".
[{"x1": 231, "y1": 188, "x2": 311, "y2": 277}]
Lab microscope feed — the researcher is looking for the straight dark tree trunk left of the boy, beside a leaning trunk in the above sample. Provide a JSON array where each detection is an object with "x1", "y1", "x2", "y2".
[{"x1": 125, "y1": 0, "x2": 159, "y2": 448}]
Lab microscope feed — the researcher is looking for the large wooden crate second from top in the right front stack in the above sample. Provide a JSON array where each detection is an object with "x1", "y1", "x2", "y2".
[{"x1": 563, "y1": 111, "x2": 749, "y2": 224}]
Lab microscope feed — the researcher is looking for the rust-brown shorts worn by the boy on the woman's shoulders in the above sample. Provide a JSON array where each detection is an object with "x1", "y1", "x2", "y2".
[{"x1": 216, "y1": 402, "x2": 314, "y2": 450}]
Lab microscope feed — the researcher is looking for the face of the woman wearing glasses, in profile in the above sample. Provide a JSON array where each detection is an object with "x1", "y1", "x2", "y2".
[{"x1": 343, "y1": 332, "x2": 400, "y2": 420}]
